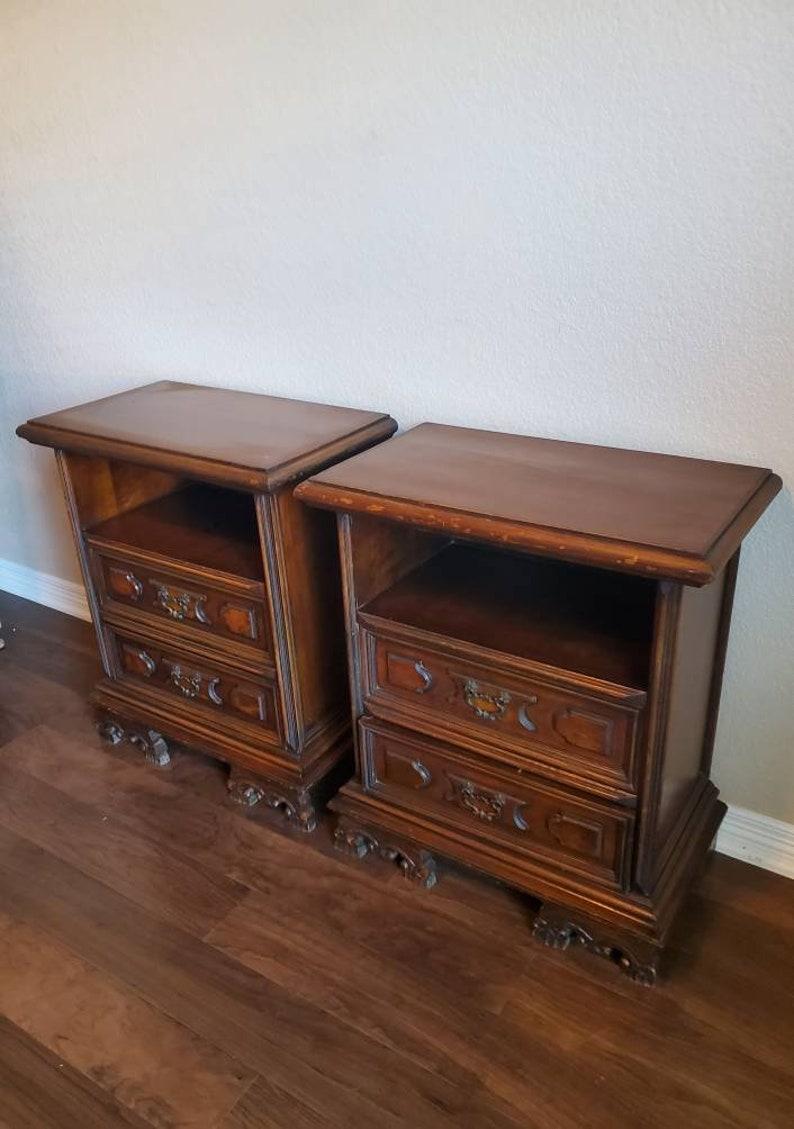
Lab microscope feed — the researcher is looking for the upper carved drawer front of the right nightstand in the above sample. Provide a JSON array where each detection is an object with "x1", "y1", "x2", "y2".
[{"x1": 365, "y1": 633, "x2": 637, "y2": 790}]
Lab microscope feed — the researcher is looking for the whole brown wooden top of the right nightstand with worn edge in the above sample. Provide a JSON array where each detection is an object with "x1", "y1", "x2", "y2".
[{"x1": 298, "y1": 423, "x2": 780, "y2": 585}]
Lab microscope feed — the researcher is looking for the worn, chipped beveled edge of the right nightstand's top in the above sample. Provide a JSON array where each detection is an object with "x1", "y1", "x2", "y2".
[{"x1": 295, "y1": 471, "x2": 782, "y2": 588}]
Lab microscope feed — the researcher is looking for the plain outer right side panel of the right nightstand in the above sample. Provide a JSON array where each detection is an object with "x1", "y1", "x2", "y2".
[{"x1": 655, "y1": 572, "x2": 725, "y2": 846}]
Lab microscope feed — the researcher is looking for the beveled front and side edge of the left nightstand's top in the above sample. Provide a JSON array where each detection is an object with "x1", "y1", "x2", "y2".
[{"x1": 16, "y1": 410, "x2": 398, "y2": 493}]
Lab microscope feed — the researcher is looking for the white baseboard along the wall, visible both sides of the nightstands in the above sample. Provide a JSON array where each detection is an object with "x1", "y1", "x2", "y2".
[{"x1": 0, "y1": 559, "x2": 794, "y2": 878}]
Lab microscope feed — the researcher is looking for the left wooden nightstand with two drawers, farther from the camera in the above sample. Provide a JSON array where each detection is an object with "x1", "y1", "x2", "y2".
[{"x1": 18, "y1": 382, "x2": 396, "y2": 831}]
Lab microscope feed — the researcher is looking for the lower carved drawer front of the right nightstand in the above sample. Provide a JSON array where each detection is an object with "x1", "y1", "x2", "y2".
[{"x1": 359, "y1": 719, "x2": 634, "y2": 886}]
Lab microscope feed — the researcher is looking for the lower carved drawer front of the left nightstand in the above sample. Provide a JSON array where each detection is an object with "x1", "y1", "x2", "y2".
[{"x1": 114, "y1": 634, "x2": 278, "y2": 733}]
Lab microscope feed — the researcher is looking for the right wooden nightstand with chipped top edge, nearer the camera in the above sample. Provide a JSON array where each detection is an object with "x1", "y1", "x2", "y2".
[{"x1": 296, "y1": 423, "x2": 780, "y2": 982}]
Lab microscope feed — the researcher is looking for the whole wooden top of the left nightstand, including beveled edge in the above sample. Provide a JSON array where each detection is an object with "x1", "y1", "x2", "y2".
[{"x1": 18, "y1": 380, "x2": 396, "y2": 490}]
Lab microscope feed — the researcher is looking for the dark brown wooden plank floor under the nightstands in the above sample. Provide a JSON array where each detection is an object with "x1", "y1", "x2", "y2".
[{"x1": 0, "y1": 594, "x2": 794, "y2": 1129}]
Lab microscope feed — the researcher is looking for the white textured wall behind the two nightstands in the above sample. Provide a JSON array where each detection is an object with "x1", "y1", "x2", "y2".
[{"x1": 0, "y1": 0, "x2": 794, "y2": 821}]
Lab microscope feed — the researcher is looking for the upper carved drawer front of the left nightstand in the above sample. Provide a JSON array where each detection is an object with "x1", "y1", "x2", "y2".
[{"x1": 97, "y1": 554, "x2": 270, "y2": 653}]
